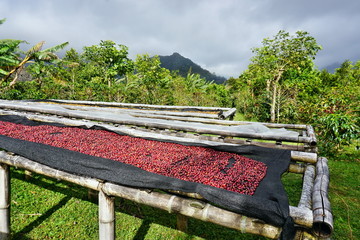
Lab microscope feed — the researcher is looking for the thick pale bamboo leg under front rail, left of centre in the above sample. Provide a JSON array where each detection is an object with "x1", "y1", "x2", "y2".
[{"x1": 99, "y1": 190, "x2": 115, "y2": 240}]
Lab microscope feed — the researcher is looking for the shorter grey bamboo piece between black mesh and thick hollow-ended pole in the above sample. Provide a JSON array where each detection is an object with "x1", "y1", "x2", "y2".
[{"x1": 298, "y1": 165, "x2": 315, "y2": 209}]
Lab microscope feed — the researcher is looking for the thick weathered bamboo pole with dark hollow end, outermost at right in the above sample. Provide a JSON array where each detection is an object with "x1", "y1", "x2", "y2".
[{"x1": 312, "y1": 157, "x2": 334, "y2": 238}]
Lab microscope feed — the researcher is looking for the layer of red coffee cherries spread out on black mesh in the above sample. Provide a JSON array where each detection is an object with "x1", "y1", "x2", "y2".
[{"x1": 0, "y1": 121, "x2": 267, "y2": 195}]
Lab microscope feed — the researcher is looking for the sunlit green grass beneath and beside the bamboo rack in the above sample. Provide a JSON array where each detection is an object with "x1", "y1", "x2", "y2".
[{"x1": 11, "y1": 148, "x2": 360, "y2": 240}]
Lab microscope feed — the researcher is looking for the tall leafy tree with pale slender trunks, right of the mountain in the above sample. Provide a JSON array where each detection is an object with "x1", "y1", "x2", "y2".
[{"x1": 249, "y1": 30, "x2": 321, "y2": 122}]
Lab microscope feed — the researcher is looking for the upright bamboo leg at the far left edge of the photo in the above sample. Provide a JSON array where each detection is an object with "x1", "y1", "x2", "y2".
[{"x1": 0, "y1": 163, "x2": 10, "y2": 240}]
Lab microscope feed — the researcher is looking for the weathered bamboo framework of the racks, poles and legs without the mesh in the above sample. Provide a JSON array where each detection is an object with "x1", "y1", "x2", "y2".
[{"x1": 0, "y1": 100, "x2": 333, "y2": 240}]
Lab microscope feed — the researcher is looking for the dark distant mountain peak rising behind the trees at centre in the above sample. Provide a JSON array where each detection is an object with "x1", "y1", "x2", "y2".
[{"x1": 159, "y1": 52, "x2": 226, "y2": 84}]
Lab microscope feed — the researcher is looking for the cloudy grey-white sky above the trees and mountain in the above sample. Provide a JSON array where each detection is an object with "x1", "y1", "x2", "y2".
[{"x1": 0, "y1": 0, "x2": 360, "y2": 77}]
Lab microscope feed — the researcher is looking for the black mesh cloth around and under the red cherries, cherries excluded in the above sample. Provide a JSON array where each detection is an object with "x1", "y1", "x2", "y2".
[{"x1": 0, "y1": 115, "x2": 294, "y2": 239}]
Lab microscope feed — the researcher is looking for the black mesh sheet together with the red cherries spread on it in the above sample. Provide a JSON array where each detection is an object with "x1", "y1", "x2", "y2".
[{"x1": 0, "y1": 115, "x2": 294, "y2": 239}]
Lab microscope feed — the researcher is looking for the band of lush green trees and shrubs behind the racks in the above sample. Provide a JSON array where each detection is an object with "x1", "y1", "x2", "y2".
[{"x1": 0, "y1": 20, "x2": 360, "y2": 152}]
